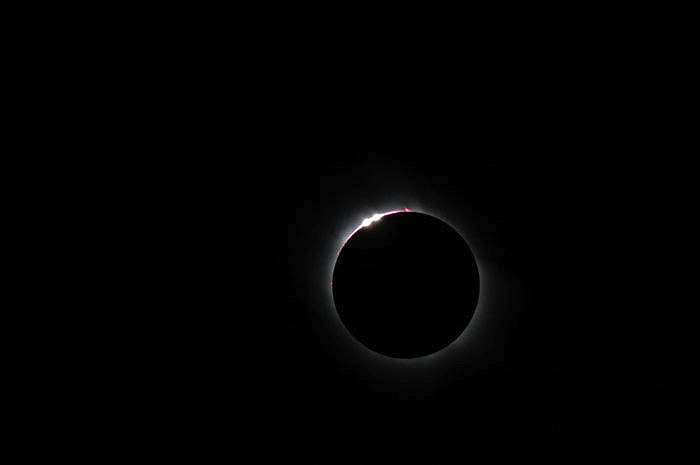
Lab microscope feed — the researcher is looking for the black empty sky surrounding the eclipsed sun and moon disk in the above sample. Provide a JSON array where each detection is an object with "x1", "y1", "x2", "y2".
[{"x1": 19, "y1": 16, "x2": 699, "y2": 464}]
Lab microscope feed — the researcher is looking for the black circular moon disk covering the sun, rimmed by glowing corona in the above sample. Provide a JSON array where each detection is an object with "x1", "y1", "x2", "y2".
[{"x1": 333, "y1": 212, "x2": 479, "y2": 358}]
